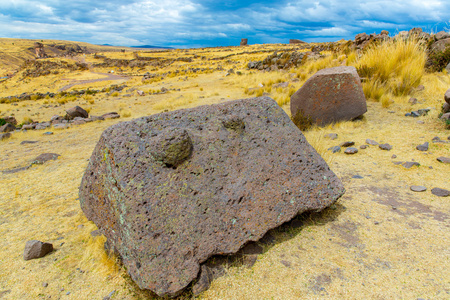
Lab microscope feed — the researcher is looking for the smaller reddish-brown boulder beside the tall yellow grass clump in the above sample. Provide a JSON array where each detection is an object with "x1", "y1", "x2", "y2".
[{"x1": 291, "y1": 67, "x2": 367, "y2": 126}]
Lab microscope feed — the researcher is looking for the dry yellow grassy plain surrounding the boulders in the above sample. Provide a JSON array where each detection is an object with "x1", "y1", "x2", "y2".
[{"x1": 0, "y1": 38, "x2": 450, "y2": 300}]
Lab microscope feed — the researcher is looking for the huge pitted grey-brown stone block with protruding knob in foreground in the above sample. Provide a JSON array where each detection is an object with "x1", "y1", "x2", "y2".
[{"x1": 80, "y1": 97, "x2": 345, "y2": 296}]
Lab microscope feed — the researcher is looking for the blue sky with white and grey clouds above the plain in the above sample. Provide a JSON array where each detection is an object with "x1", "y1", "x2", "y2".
[{"x1": 0, "y1": 0, "x2": 450, "y2": 48}]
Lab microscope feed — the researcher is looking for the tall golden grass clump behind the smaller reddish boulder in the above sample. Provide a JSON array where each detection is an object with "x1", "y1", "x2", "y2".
[{"x1": 355, "y1": 39, "x2": 427, "y2": 101}]
